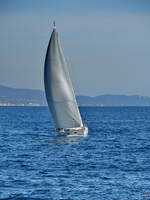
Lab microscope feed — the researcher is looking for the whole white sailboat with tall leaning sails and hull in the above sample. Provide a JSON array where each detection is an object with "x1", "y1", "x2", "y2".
[{"x1": 44, "y1": 22, "x2": 88, "y2": 136}]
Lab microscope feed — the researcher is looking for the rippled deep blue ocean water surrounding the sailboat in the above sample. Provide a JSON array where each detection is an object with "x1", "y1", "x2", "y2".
[{"x1": 0, "y1": 107, "x2": 150, "y2": 200}]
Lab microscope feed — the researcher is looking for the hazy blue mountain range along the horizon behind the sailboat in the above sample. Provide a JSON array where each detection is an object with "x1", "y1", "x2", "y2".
[{"x1": 0, "y1": 86, "x2": 150, "y2": 106}]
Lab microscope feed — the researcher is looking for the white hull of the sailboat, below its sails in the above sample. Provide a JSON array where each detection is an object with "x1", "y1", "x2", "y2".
[{"x1": 56, "y1": 126, "x2": 88, "y2": 137}]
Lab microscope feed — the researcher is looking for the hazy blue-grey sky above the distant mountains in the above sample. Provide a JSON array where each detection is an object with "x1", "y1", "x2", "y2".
[{"x1": 0, "y1": 0, "x2": 150, "y2": 96}]
